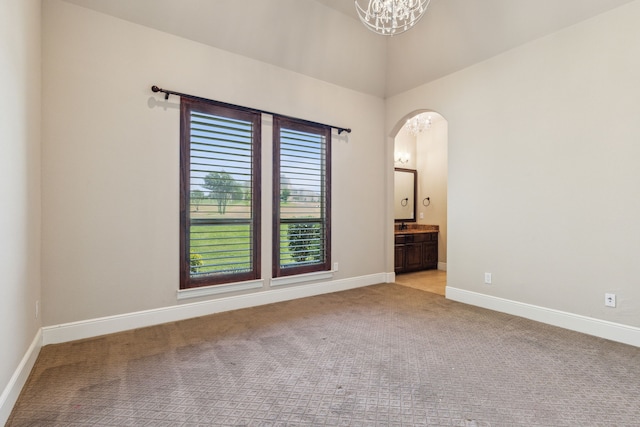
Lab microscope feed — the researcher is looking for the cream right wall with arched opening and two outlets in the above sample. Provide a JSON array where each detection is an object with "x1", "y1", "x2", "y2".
[{"x1": 387, "y1": 1, "x2": 640, "y2": 327}]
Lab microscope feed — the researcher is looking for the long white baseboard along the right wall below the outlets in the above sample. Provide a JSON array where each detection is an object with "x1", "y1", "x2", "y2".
[{"x1": 446, "y1": 286, "x2": 640, "y2": 347}]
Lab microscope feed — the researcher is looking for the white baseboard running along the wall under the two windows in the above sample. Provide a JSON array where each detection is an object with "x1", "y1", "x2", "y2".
[{"x1": 42, "y1": 273, "x2": 388, "y2": 345}]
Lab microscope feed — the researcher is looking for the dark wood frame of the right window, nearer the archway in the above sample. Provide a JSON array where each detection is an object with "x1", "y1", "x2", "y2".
[{"x1": 272, "y1": 116, "x2": 332, "y2": 278}]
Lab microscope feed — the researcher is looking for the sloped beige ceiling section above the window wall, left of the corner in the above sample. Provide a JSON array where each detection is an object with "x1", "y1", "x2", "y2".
[{"x1": 65, "y1": 0, "x2": 388, "y2": 97}]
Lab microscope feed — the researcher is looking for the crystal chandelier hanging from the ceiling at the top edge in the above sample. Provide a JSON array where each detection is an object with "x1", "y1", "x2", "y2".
[{"x1": 355, "y1": 0, "x2": 431, "y2": 36}]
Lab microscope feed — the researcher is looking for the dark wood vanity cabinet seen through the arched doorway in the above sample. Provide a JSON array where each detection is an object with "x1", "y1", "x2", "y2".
[{"x1": 394, "y1": 232, "x2": 438, "y2": 273}]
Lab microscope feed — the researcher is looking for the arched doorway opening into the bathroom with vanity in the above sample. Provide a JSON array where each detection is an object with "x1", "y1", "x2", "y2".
[{"x1": 392, "y1": 110, "x2": 448, "y2": 295}]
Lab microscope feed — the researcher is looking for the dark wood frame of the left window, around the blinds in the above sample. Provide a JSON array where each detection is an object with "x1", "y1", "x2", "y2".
[{"x1": 180, "y1": 98, "x2": 262, "y2": 290}]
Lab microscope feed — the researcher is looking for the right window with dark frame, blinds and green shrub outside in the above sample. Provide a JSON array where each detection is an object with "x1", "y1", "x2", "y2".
[{"x1": 273, "y1": 116, "x2": 331, "y2": 277}]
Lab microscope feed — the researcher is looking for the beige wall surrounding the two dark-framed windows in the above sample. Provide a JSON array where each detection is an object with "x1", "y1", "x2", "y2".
[{"x1": 42, "y1": 0, "x2": 392, "y2": 325}]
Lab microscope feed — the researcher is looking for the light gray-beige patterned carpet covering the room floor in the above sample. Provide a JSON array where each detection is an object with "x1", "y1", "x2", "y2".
[{"x1": 8, "y1": 284, "x2": 640, "y2": 427}]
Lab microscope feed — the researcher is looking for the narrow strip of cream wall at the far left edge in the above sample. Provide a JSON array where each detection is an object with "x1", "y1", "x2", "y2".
[{"x1": 0, "y1": 0, "x2": 40, "y2": 424}]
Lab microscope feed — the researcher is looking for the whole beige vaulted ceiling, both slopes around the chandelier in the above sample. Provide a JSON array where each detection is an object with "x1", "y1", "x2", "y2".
[{"x1": 64, "y1": 0, "x2": 638, "y2": 97}]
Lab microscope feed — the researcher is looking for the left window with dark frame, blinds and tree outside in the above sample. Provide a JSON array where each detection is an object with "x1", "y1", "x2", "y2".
[{"x1": 180, "y1": 98, "x2": 261, "y2": 289}]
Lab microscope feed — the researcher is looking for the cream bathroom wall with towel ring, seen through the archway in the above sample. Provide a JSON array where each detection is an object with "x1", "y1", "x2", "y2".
[{"x1": 416, "y1": 117, "x2": 449, "y2": 268}]
